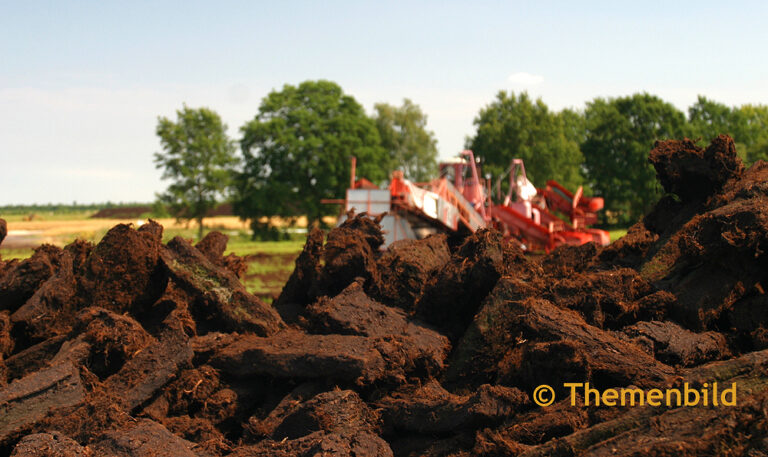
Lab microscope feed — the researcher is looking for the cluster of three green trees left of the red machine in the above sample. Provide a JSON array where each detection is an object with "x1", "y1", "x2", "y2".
[{"x1": 155, "y1": 80, "x2": 437, "y2": 236}]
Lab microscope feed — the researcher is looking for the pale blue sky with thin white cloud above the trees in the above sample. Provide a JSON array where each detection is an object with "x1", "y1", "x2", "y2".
[{"x1": 0, "y1": 0, "x2": 768, "y2": 204}]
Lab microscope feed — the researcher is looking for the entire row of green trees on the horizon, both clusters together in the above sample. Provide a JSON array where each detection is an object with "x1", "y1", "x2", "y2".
[{"x1": 155, "y1": 80, "x2": 768, "y2": 235}]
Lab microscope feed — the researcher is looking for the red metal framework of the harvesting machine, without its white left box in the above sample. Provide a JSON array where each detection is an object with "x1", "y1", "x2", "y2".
[{"x1": 328, "y1": 150, "x2": 608, "y2": 252}]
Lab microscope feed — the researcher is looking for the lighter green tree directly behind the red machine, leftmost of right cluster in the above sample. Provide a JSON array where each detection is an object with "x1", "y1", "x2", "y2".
[{"x1": 467, "y1": 91, "x2": 583, "y2": 190}]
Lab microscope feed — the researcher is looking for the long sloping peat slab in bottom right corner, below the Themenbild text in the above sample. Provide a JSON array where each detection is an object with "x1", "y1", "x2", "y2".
[{"x1": 520, "y1": 351, "x2": 768, "y2": 457}]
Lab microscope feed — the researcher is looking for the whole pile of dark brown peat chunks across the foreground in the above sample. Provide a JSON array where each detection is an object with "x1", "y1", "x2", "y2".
[{"x1": 0, "y1": 136, "x2": 768, "y2": 457}]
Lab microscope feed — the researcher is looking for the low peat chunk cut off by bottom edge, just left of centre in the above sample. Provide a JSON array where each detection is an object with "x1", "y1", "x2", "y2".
[{"x1": 229, "y1": 432, "x2": 392, "y2": 457}]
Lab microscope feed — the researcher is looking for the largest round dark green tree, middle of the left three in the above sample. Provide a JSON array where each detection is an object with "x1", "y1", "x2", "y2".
[{"x1": 235, "y1": 81, "x2": 389, "y2": 230}]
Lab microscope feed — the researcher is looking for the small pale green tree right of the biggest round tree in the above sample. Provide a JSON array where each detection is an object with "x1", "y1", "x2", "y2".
[{"x1": 374, "y1": 98, "x2": 437, "y2": 181}]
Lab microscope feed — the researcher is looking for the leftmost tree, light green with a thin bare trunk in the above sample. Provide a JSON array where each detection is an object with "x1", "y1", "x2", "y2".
[{"x1": 155, "y1": 105, "x2": 237, "y2": 238}]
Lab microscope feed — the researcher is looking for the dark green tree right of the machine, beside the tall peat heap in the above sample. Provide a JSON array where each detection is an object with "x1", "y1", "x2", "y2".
[{"x1": 581, "y1": 93, "x2": 687, "y2": 223}]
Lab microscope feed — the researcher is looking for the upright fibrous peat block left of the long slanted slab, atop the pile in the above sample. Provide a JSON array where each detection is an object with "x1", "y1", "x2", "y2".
[{"x1": 79, "y1": 220, "x2": 167, "y2": 313}]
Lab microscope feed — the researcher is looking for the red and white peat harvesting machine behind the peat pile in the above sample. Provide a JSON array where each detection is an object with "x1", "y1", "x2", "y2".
[{"x1": 329, "y1": 151, "x2": 609, "y2": 252}]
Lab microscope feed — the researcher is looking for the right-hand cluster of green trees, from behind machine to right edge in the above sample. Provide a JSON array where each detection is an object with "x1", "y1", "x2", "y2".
[{"x1": 467, "y1": 91, "x2": 768, "y2": 225}]
